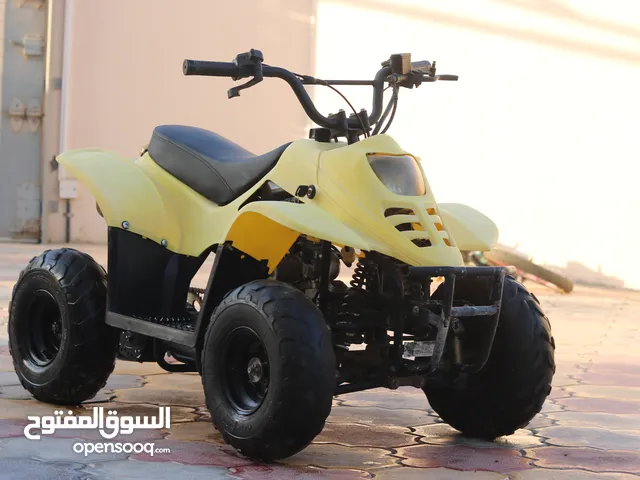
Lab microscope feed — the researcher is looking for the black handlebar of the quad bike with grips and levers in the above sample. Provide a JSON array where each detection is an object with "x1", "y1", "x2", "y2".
[{"x1": 182, "y1": 50, "x2": 457, "y2": 130}]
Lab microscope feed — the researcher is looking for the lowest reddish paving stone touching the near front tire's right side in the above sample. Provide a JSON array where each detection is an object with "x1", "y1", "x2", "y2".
[{"x1": 282, "y1": 444, "x2": 396, "y2": 470}]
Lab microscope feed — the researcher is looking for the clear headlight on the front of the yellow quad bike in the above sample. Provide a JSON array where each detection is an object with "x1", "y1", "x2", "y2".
[{"x1": 367, "y1": 153, "x2": 427, "y2": 196}]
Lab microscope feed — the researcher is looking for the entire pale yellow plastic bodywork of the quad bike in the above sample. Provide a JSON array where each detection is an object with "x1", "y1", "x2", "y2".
[{"x1": 58, "y1": 135, "x2": 484, "y2": 270}]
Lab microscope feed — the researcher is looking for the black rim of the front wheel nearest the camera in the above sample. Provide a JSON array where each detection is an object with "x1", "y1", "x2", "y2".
[{"x1": 223, "y1": 327, "x2": 270, "y2": 415}]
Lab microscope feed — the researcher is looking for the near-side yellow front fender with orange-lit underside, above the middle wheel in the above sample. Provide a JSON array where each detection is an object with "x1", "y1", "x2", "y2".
[{"x1": 226, "y1": 202, "x2": 386, "y2": 271}]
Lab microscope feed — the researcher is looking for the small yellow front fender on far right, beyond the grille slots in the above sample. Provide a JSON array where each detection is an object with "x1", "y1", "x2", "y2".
[{"x1": 438, "y1": 203, "x2": 498, "y2": 252}]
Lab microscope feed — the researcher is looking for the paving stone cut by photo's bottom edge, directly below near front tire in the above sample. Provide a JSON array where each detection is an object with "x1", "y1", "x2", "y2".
[{"x1": 229, "y1": 465, "x2": 373, "y2": 480}]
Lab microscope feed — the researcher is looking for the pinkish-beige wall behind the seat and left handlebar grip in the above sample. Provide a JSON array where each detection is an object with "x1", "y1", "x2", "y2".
[{"x1": 45, "y1": 0, "x2": 315, "y2": 242}]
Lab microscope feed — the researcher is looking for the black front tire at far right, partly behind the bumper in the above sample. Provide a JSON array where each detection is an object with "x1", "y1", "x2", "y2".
[{"x1": 424, "y1": 277, "x2": 555, "y2": 439}]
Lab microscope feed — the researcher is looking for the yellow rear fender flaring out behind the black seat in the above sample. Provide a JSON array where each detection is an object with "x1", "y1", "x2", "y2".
[{"x1": 57, "y1": 148, "x2": 181, "y2": 245}]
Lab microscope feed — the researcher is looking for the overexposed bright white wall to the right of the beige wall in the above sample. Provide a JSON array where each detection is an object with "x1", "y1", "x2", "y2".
[{"x1": 317, "y1": 0, "x2": 640, "y2": 287}]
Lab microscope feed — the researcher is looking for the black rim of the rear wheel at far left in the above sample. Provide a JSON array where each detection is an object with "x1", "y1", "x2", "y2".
[{"x1": 22, "y1": 290, "x2": 62, "y2": 367}]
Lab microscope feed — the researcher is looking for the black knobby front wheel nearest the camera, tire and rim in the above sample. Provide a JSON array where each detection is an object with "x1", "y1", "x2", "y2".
[{"x1": 202, "y1": 280, "x2": 336, "y2": 460}]
